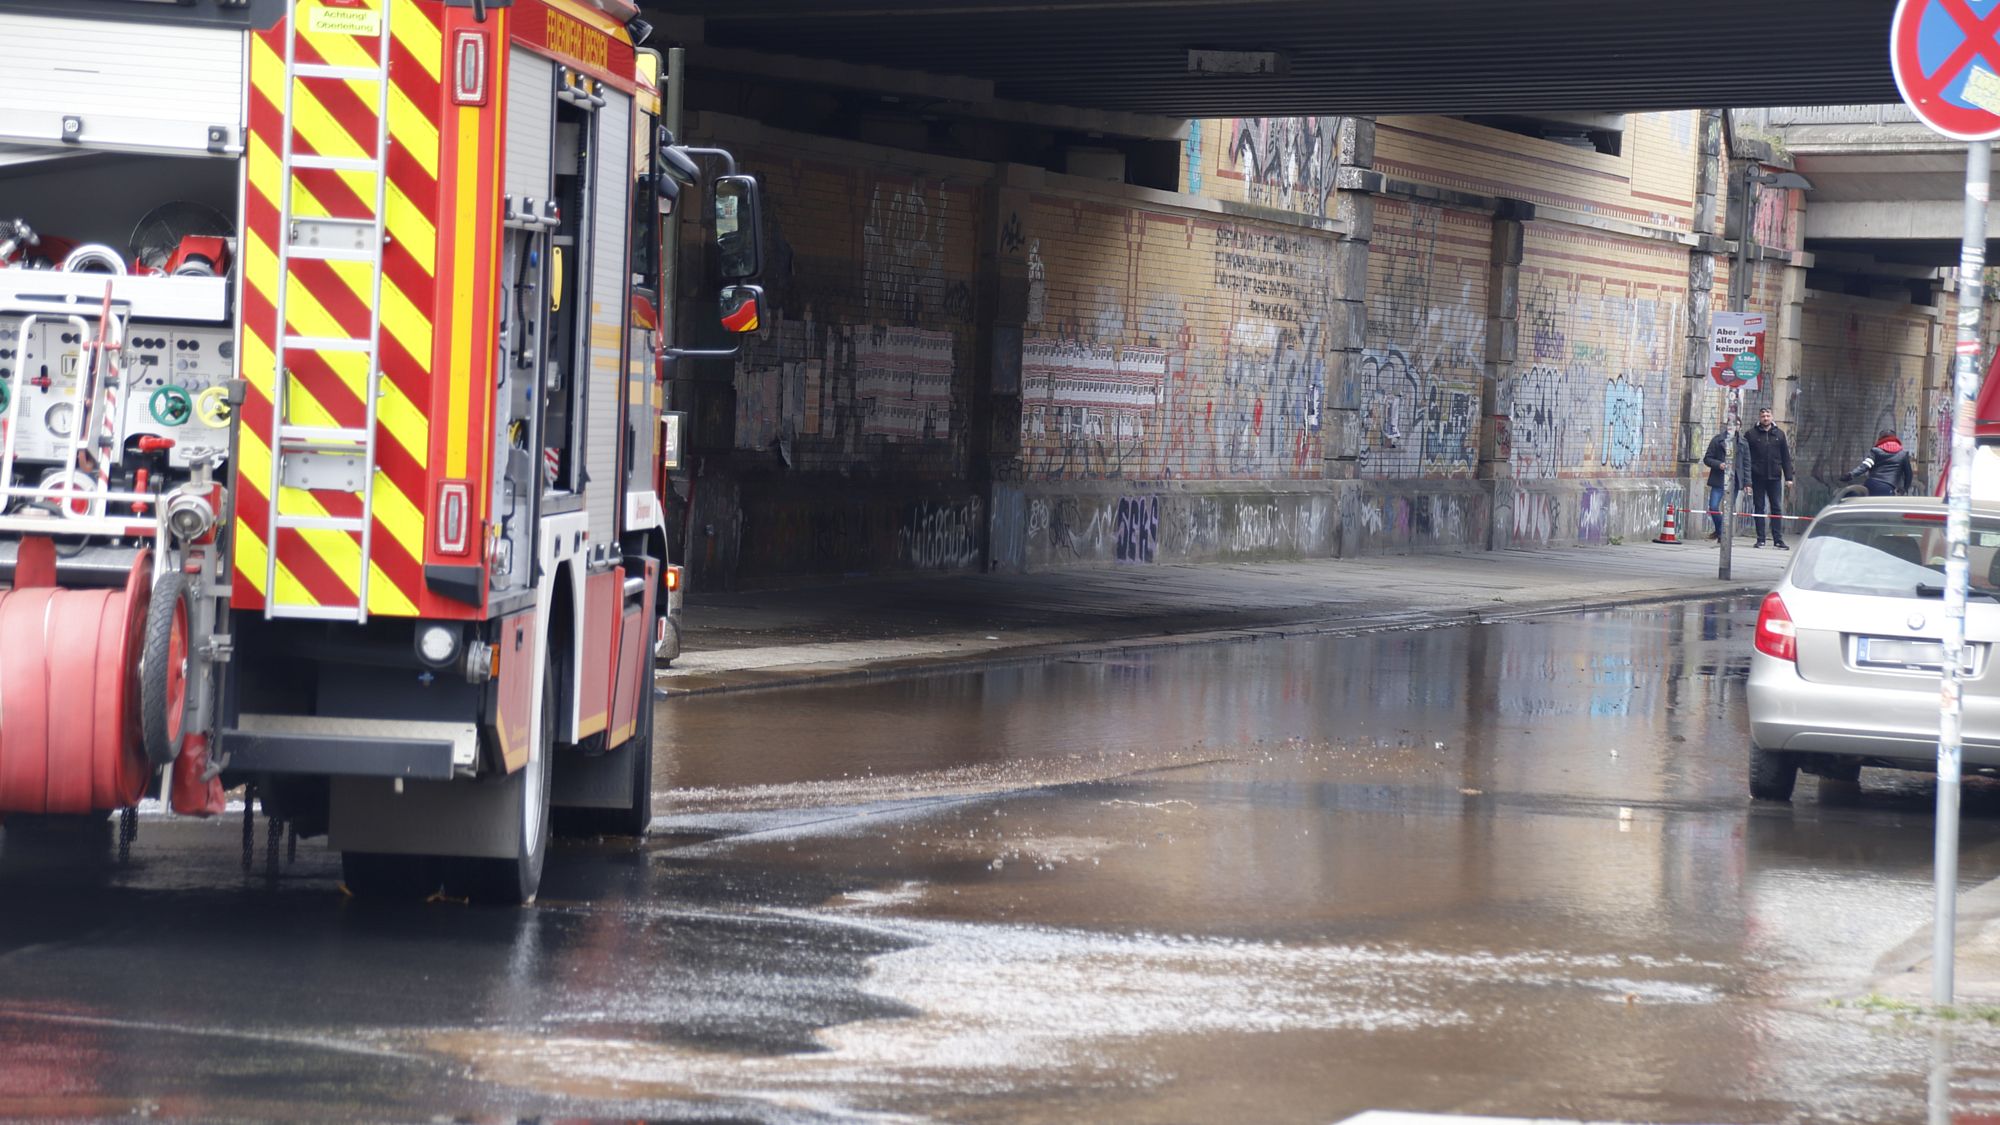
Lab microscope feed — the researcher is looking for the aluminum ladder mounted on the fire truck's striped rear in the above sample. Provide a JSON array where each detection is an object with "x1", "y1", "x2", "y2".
[{"x1": 264, "y1": 0, "x2": 394, "y2": 623}]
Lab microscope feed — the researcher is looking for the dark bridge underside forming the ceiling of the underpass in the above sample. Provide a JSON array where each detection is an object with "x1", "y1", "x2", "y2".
[{"x1": 648, "y1": 0, "x2": 1896, "y2": 118}]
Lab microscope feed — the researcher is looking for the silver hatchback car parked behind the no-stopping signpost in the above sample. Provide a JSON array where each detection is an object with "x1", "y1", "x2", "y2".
[{"x1": 1750, "y1": 496, "x2": 2000, "y2": 801}]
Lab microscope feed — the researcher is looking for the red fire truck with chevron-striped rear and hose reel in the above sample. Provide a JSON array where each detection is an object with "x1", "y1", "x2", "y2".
[{"x1": 0, "y1": 0, "x2": 760, "y2": 903}]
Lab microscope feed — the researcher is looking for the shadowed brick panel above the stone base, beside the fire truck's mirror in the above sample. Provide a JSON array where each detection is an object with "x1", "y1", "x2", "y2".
[{"x1": 690, "y1": 123, "x2": 990, "y2": 480}]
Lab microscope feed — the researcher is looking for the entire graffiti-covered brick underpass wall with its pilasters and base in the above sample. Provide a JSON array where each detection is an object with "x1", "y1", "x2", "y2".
[{"x1": 676, "y1": 114, "x2": 1736, "y2": 585}]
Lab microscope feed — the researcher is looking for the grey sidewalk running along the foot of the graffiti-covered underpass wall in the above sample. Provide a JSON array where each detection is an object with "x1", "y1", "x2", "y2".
[{"x1": 660, "y1": 540, "x2": 1790, "y2": 695}]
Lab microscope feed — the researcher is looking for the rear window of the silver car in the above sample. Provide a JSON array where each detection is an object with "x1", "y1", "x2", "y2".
[{"x1": 1792, "y1": 512, "x2": 2000, "y2": 597}]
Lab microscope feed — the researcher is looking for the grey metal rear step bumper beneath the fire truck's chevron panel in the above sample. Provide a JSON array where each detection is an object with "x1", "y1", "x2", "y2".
[{"x1": 222, "y1": 715, "x2": 480, "y2": 781}]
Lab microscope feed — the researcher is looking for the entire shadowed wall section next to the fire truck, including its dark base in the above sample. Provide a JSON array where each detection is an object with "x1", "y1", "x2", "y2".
[{"x1": 670, "y1": 116, "x2": 992, "y2": 587}]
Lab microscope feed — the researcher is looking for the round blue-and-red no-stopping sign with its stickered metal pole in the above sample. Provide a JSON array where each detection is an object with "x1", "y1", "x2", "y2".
[{"x1": 1888, "y1": 0, "x2": 2000, "y2": 1007}]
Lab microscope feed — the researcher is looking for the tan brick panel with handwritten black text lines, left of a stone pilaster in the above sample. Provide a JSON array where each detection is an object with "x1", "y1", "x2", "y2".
[{"x1": 1018, "y1": 192, "x2": 1332, "y2": 480}]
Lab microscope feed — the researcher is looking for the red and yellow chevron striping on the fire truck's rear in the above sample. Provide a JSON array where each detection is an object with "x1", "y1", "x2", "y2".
[{"x1": 234, "y1": 0, "x2": 504, "y2": 617}]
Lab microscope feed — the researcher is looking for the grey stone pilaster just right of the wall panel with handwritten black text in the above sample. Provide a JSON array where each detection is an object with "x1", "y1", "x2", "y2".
[{"x1": 1320, "y1": 118, "x2": 1374, "y2": 556}]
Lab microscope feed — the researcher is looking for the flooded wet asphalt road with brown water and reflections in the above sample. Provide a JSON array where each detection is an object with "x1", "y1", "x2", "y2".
[{"x1": 0, "y1": 601, "x2": 2000, "y2": 1121}]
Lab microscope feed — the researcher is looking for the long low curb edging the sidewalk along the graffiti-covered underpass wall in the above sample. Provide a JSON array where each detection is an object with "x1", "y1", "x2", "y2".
[{"x1": 654, "y1": 581, "x2": 1770, "y2": 699}]
